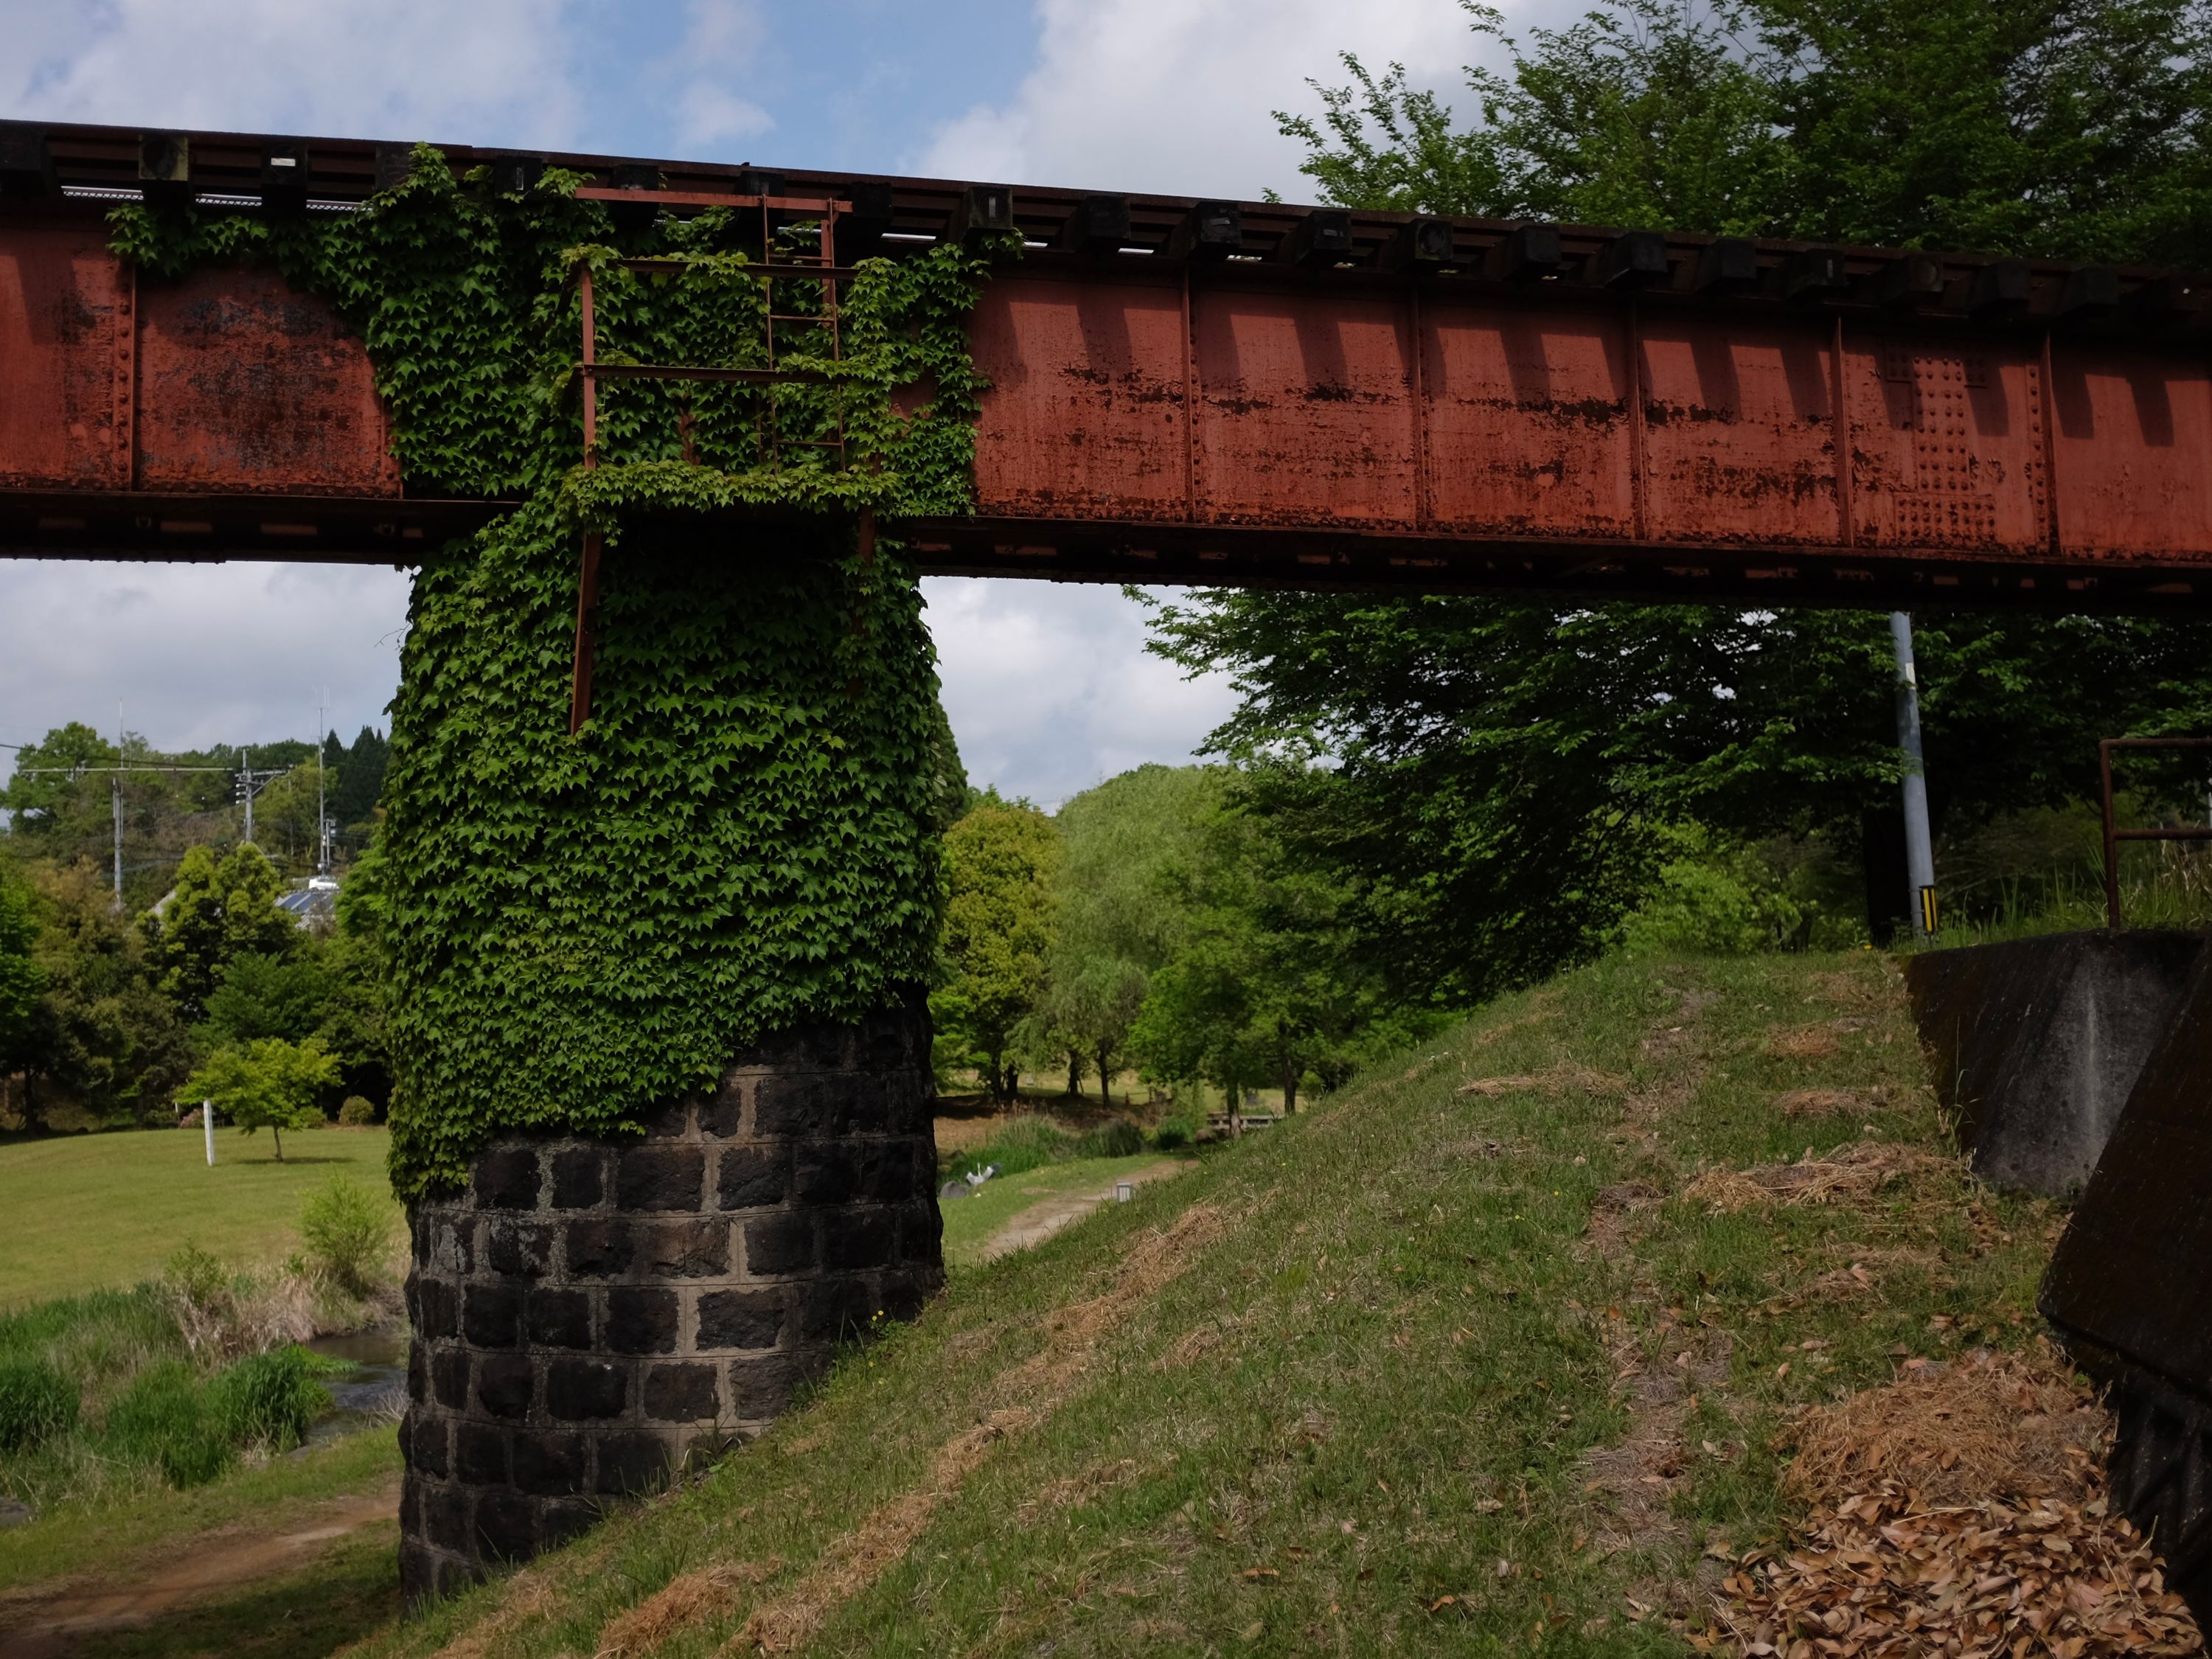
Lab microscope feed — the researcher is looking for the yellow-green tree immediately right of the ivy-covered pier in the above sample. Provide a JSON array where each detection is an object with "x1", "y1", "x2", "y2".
[{"x1": 931, "y1": 799, "x2": 1060, "y2": 1099}]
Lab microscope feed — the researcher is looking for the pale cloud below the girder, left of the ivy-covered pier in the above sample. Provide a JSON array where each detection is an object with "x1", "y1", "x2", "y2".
[{"x1": 0, "y1": 560, "x2": 407, "y2": 774}]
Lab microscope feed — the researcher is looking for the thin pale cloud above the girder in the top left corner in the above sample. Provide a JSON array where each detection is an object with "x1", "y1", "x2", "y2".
[{"x1": 0, "y1": 0, "x2": 580, "y2": 146}]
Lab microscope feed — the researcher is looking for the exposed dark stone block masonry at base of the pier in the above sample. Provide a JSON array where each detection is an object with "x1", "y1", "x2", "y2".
[{"x1": 400, "y1": 1006, "x2": 945, "y2": 1601}]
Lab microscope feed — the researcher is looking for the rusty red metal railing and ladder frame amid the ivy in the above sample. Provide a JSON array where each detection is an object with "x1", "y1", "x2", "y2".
[{"x1": 568, "y1": 188, "x2": 854, "y2": 737}]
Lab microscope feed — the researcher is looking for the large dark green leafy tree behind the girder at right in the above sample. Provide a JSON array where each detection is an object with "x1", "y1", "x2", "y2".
[{"x1": 1155, "y1": 0, "x2": 2212, "y2": 1002}]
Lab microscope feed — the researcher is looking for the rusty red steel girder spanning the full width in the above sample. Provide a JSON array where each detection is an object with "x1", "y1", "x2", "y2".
[{"x1": 0, "y1": 124, "x2": 2212, "y2": 608}]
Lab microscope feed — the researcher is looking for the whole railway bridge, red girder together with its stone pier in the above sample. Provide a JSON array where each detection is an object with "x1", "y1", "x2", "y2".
[{"x1": 0, "y1": 124, "x2": 2212, "y2": 1595}]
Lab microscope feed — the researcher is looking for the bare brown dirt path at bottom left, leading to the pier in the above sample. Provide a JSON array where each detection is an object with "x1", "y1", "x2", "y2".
[{"x1": 0, "y1": 1480, "x2": 400, "y2": 1659}]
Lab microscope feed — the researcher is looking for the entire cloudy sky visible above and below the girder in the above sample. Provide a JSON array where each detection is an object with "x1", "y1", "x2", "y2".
[{"x1": 0, "y1": 0, "x2": 1513, "y2": 805}]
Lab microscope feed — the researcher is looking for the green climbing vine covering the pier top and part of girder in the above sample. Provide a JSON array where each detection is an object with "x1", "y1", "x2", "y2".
[{"x1": 113, "y1": 148, "x2": 1004, "y2": 1197}]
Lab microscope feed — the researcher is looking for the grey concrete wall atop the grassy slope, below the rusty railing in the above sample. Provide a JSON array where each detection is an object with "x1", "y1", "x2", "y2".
[{"x1": 1905, "y1": 929, "x2": 2203, "y2": 1197}]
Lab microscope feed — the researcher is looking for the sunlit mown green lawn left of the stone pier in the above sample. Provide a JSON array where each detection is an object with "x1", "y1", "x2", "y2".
[{"x1": 0, "y1": 1128, "x2": 398, "y2": 1307}]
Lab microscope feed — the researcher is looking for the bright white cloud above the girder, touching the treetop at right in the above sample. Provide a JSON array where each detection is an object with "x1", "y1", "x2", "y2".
[{"x1": 914, "y1": 0, "x2": 1478, "y2": 201}]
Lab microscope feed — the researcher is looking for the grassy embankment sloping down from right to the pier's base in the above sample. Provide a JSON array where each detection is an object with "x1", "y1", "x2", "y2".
[{"x1": 365, "y1": 953, "x2": 2057, "y2": 1659}]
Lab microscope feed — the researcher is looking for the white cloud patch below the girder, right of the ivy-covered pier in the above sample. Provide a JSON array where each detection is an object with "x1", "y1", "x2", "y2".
[{"x1": 922, "y1": 577, "x2": 1237, "y2": 810}]
